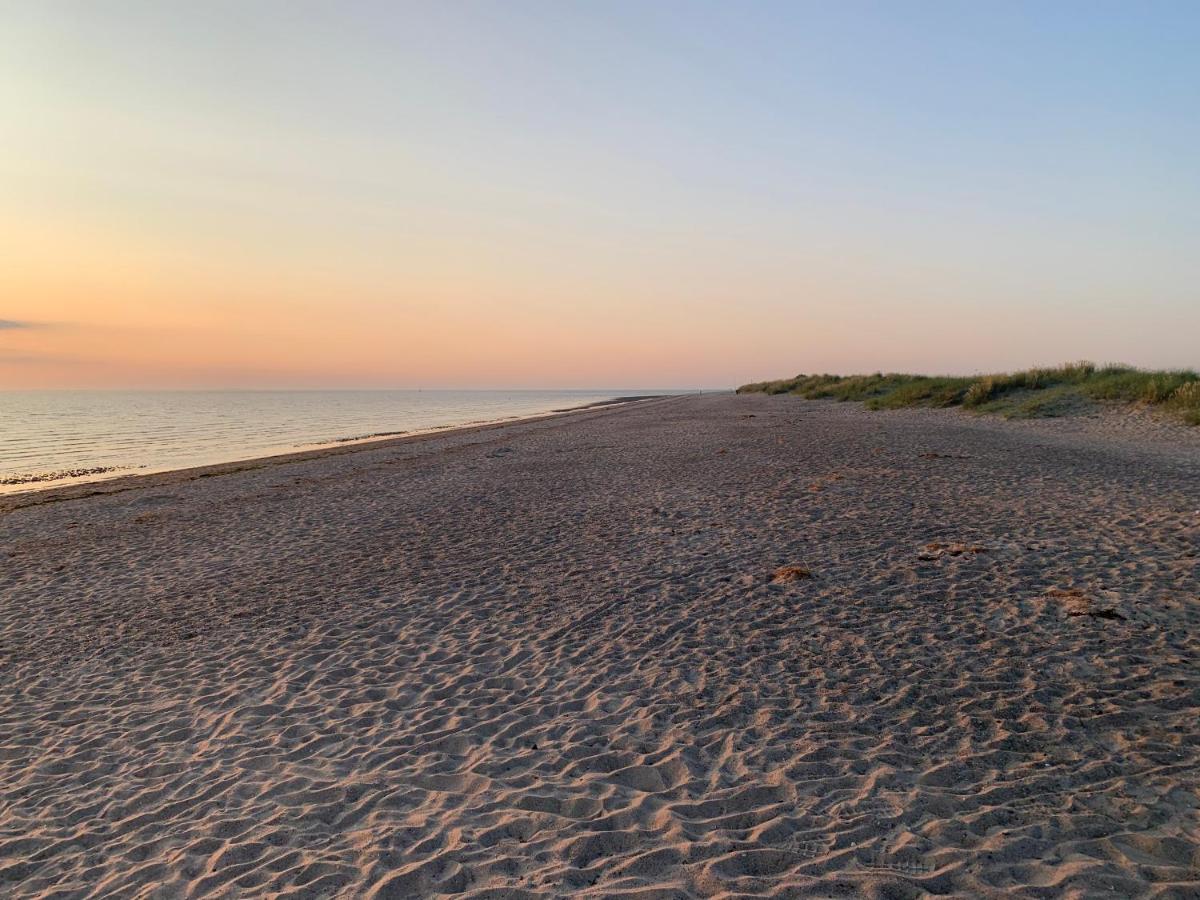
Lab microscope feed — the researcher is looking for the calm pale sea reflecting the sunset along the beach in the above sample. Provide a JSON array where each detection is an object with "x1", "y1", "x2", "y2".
[{"x1": 0, "y1": 391, "x2": 655, "y2": 492}]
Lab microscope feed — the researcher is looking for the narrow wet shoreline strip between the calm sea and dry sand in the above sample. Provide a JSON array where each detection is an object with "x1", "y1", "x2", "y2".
[{"x1": 0, "y1": 394, "x2": 676, "y2": 516}]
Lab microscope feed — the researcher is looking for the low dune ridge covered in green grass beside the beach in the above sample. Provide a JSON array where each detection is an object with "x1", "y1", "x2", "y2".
[{"x1": 738, "y1": 362, "x2": 1200, "y2": 425}]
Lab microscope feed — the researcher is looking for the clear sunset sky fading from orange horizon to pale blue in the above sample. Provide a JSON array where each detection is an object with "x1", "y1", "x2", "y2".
[{"x1": 0, "y1": 0, "x2": 1200, "y2": 389}]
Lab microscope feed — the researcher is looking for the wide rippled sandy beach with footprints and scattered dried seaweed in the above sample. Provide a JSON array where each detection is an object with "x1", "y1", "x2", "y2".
[{"x1": 0, "y1": 396, "x2": 1200, "y2": 900}]
